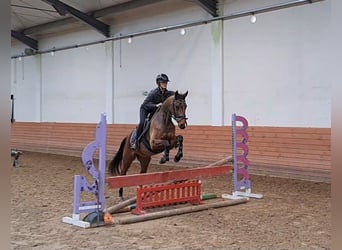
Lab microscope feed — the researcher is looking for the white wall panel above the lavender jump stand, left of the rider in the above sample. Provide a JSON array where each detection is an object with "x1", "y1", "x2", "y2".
[{"x1": 42, "y1": 44, "x2": 111, "y2": 122}]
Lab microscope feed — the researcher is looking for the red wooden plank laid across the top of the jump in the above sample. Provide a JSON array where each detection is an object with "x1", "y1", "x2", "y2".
[{"x1": 106, "y1": 165, "x2": 233, "y2": 188}]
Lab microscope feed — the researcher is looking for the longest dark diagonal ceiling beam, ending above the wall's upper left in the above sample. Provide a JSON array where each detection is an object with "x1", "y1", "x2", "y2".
[{"x1": 42, "y1": 0, "x2": 109, "y2": 37}]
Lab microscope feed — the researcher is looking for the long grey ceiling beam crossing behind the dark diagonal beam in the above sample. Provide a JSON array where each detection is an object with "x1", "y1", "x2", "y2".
[{"x1": 22, "y1": 0, "x2": 165, "y2": 35}]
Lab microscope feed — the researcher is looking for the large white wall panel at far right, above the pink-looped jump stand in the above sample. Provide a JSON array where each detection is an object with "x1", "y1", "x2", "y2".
[{"x1": 224, "y1": 3, "x2": 332, "y2": 127}]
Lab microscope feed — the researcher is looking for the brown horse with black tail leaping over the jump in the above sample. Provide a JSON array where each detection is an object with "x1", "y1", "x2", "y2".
[{"x1": 109, "y1": 91, "x2": 188, "y2": 199}]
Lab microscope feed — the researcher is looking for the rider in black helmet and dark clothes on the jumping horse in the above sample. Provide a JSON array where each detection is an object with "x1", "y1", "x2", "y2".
[{"x1": 131, "y1": 74, "x2": 175, "y2": 149}]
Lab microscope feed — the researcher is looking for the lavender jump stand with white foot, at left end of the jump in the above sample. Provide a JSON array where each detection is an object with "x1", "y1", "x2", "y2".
[{"x1": 62, "y1": 113, "x2": 107, "y2": 228}]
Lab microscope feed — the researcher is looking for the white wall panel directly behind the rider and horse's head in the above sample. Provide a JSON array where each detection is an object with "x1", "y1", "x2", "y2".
[{"x1": 114, "y1": 25, "x2": 211, "y2": 124}]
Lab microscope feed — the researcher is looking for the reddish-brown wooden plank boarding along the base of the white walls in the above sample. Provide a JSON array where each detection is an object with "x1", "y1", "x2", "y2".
[{"x1": 11, "y1": 122, "x2": 331, "y2": 182}]
